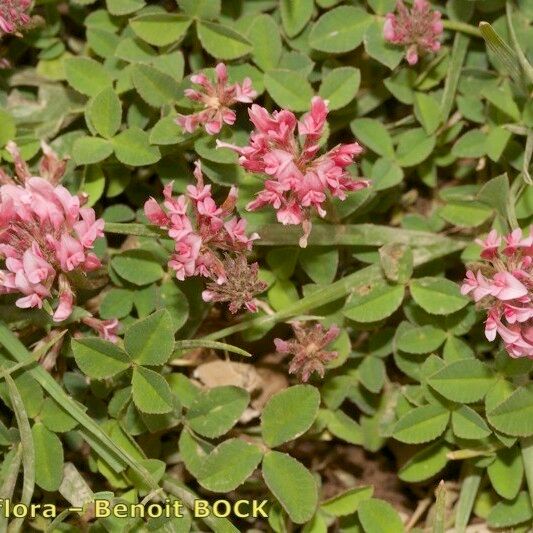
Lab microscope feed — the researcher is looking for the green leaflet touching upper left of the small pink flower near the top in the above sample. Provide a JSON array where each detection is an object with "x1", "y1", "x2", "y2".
[{"x1": 131, "y1": 63, "x2": 181, "y2": 107}]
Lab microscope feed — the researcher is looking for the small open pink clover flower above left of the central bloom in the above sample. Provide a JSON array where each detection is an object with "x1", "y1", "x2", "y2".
[{"x1": 176, "y1": 63, "x2": 257, "y2": 135}]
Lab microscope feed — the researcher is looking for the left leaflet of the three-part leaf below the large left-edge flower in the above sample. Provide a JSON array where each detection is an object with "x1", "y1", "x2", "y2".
[{"x1": 72, "y1": 337, "x2": 130, "y2": 379}]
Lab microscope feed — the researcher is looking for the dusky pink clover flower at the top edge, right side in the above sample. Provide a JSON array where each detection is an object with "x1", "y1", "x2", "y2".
[{"x1": 383, "y1": 0, "x2": 443, "y2": 65}]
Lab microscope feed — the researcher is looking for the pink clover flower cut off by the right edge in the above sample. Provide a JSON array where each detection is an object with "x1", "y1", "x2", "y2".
[{"x1": 461, "y1": 227, "x2": 533, "y2": 358}]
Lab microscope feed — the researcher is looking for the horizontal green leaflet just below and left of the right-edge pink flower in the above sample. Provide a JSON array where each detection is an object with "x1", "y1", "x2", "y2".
[{"x1": 428, "y1": 359, "x2": 494, "y2": 403}]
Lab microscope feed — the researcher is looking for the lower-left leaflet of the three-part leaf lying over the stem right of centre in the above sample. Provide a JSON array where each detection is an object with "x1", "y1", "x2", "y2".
[{"x1": 343, "y1": 285, "x2": 405, "y2": 323}]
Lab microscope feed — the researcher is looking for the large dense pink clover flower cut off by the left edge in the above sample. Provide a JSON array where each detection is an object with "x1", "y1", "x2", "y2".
[{"x1": 0, "y1": 142, "x2": 104, "y2": 322}]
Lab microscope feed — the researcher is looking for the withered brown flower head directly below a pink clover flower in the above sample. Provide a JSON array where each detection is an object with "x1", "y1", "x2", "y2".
[{"x1": 202, "y1": 254, "x2": 267, "y2": 313}]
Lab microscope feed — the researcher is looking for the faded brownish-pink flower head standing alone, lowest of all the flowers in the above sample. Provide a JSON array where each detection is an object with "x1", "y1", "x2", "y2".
[{"x1": 274, "y1": 323, "x2": 340, "y2": 382}]
